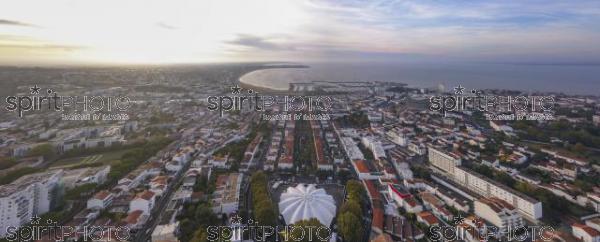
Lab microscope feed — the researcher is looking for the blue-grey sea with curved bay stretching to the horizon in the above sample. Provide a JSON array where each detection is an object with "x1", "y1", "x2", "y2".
[{"x1": 242, "y1": 63, "x2": 600, "y2": 95}]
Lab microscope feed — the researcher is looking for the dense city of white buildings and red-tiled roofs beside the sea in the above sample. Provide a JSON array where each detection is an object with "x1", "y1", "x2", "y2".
[{"x1": 0, "y1": 64, "x2": 600, "y2": 241}]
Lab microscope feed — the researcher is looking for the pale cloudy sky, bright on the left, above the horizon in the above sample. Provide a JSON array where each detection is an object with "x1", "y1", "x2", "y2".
[{"x1": 0, "y1": 0, "x2": 600, "y2": 65}]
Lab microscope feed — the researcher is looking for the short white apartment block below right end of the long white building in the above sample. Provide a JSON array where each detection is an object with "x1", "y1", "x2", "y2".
[{"x1": 474, "y1": 197, "x2": 524, "y2": 232}]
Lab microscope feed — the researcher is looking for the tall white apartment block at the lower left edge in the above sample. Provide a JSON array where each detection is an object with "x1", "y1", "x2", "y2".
[{"x1": 0, "y1": 170, "x2": 63, "y2": 238}]
